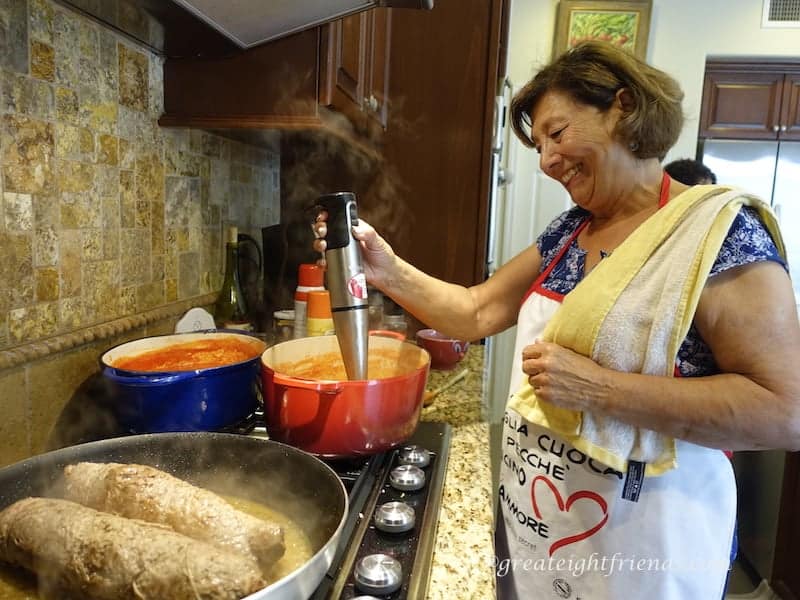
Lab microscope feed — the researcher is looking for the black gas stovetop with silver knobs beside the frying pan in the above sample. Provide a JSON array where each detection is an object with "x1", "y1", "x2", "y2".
[{"x1": 250, "y1": 422, "x2": 451, "y2": 600}]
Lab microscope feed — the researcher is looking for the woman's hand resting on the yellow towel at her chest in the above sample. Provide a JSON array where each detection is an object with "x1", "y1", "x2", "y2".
[{"x1": 522, "y1": 341, "x2": 606, "y2": 411}]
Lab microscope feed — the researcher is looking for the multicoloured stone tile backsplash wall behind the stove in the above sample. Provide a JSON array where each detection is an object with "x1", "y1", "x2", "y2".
[{"x1": 0, "y1": 0, "x2": 280, "y2": 465}]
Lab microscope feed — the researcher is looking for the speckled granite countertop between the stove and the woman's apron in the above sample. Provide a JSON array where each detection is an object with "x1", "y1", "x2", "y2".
[{"x1": 422, "y1": 345, "x2": 495, "y2": 600}]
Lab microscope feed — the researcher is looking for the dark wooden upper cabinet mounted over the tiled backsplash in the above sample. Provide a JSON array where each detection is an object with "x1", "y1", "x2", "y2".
[{"x1": 159, "y1": 8, "x2": 391, "y2": 137}]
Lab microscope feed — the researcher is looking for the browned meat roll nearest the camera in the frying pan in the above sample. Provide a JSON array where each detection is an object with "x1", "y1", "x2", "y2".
[{"x1": 0, "y1": 498, "x2": 266, "y2": 600}]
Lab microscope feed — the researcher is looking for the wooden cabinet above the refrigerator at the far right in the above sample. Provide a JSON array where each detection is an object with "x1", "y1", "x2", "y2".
[{"x1": 699, "y1": 59, "x2": 800, "y2": 140}]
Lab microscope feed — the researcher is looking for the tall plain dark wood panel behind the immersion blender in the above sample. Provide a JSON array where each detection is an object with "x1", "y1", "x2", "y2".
[{"x1": 281, "y1": 0, "x2": 507, "y2": 285}]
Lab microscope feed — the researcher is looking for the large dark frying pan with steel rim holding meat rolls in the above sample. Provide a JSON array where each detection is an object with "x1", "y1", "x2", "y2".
[{"x1": 0, "y1": 432, "x2": 348, "y2": 600}]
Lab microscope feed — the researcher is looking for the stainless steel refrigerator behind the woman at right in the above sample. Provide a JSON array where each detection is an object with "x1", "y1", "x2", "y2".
[{"x1": 701, "y1": 140, "x2": 800, "y2": 580}]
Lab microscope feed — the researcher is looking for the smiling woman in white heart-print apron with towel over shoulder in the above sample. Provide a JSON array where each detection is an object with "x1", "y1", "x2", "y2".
[{"x1": 316, "y1": 39, "x2": 800, "y2": 600}]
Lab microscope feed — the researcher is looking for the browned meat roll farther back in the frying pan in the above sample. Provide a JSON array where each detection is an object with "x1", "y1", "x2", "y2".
[{"x1": 64, "y1": 462, "x2": 284, "y2": 572}]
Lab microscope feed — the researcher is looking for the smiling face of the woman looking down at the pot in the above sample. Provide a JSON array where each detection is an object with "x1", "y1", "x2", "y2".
[{"x1": 531, "y1": 91, "x2": 633, "y2": 211}]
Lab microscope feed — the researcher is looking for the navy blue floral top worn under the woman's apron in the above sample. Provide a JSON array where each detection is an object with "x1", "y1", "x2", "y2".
[{"x1": 536, "y1": 206, "x2": 786, "y2": 377}]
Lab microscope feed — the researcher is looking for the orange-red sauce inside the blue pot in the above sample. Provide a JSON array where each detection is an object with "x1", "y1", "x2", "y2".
[{"x1": 111, "y1": 337, "x2": 261, "y2": 371}]
